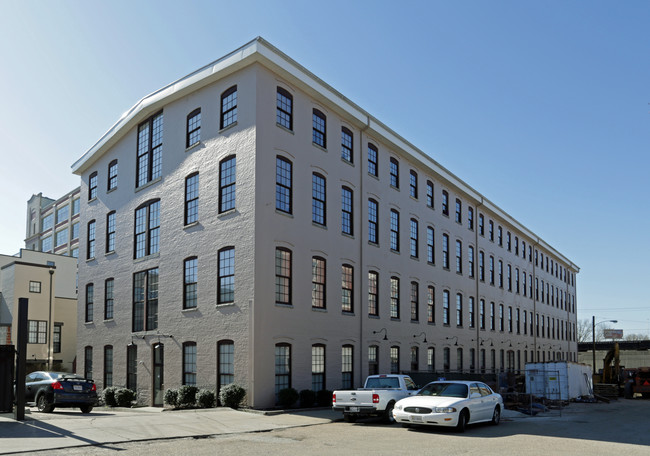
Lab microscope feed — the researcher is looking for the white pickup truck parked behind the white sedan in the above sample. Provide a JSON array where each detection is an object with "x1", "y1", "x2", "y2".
[{"x1": 332, "y1": 374, "x2": 419, "y2": 423}]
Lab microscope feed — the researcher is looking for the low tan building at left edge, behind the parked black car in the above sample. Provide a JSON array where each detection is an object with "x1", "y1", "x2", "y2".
[{"x1": 0, "y1": 249, "x2": 77, "y2": 372}]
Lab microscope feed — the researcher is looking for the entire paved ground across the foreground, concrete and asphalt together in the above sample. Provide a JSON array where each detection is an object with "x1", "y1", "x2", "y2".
[{"x1": 0, "y1": 399, "x2": 650, "y2": 456}]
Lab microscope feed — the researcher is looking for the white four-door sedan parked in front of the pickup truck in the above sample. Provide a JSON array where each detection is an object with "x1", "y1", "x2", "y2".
[{"x1": 393, "y1": 381, "x2": 503, "y2": 432}]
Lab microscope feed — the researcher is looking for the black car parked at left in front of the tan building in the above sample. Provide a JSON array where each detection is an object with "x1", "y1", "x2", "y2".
[{"x1": 25, "y1": 371, "x2": 97, "y2": 413}]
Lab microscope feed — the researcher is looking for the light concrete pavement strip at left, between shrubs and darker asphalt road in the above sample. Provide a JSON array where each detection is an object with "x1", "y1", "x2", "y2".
[{"x1": 0, "y1": 407, "x2": 341, "y2": 454}]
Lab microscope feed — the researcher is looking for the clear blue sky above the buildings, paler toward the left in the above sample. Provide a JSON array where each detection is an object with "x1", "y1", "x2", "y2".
[{"x1": 0, "y1": 0, "x2": 650, "y2": 335}]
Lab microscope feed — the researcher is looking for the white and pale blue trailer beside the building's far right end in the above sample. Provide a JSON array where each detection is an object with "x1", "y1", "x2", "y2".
[{"x1": 526, "y1": 361, "x2": 593, "y2": 401}]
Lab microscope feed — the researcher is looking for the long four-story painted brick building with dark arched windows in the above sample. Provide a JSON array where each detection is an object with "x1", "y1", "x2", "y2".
[{"x1": 73, "y1": 38, "x2": 578, "y2": 407}]
